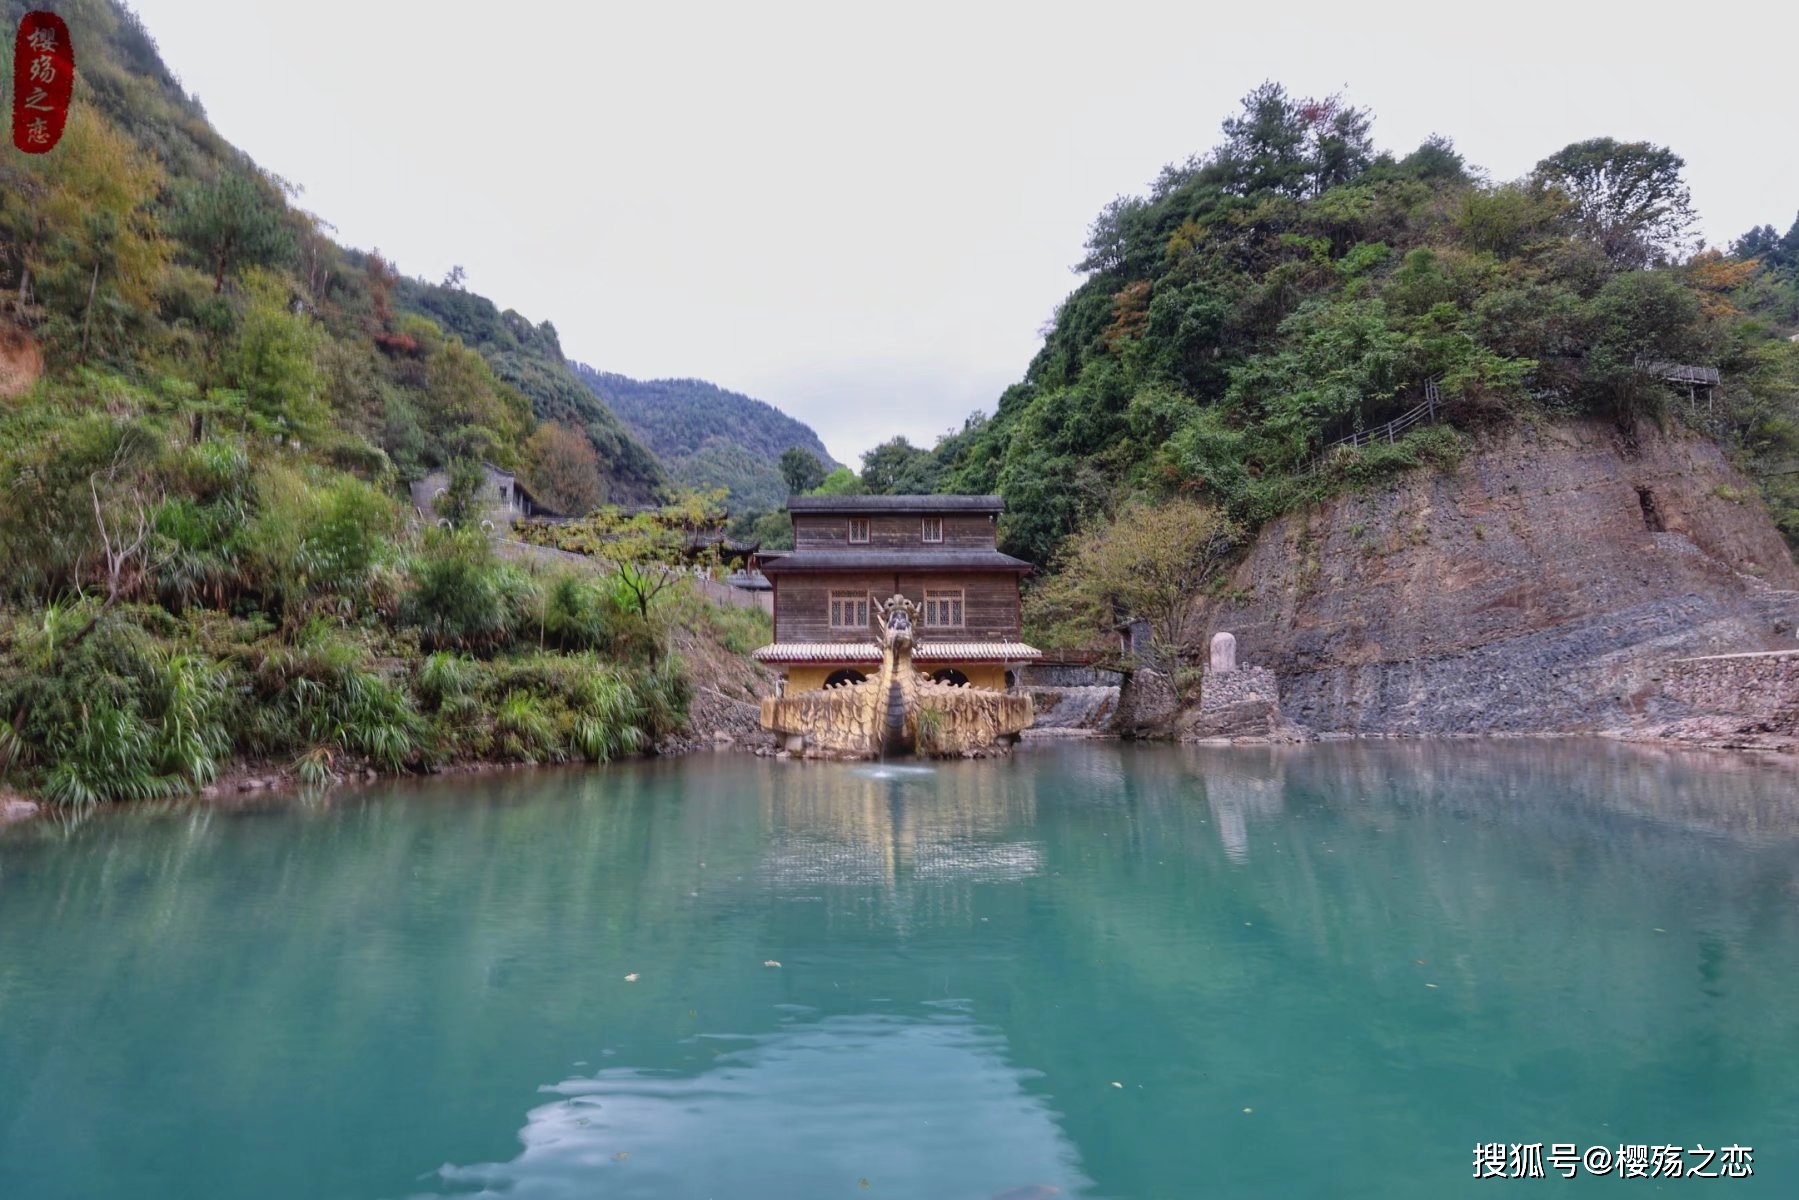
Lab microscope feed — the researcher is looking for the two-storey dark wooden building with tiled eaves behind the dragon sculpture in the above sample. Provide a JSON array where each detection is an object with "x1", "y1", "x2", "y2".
[{"x1": 756, "y1": 497, "x2": 1040, "y2": 693}]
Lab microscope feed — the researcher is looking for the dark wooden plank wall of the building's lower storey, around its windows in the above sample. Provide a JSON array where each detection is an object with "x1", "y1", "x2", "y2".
[{"x1": 775, "y1": 572, "x2": 1018, "y2": 642}]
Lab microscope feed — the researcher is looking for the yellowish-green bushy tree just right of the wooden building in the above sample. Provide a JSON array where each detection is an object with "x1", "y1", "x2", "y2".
[{"x1": 1027, "y1": 500, "x2": 1243, "y2": 669}]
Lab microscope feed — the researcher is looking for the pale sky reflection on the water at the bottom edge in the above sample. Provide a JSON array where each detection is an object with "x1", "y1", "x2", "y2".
[{"x1": 426, "y1": 1011, "x2": 1090, "y2": 1200}]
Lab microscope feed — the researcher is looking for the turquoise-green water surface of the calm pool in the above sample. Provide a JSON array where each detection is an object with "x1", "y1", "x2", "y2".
[{"x1": 0, "y1": 743, "x2": 1799, "y2": 1200}]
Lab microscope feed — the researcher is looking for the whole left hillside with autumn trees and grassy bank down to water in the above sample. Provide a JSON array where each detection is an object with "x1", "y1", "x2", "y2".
[{"x1": 0, "y1": 0, "x2": 763, "y2": 804}]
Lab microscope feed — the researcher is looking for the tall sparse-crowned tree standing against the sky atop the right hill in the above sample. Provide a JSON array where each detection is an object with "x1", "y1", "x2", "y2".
[{"x1": 1531, "y1": 137, "x2": 1698, "y2": 270}]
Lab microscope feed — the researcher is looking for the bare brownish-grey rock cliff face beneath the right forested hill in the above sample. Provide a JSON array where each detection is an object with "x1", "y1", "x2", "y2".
[{"x1": 1195, "y1": 423, "x2": 1799, "y2": 734}]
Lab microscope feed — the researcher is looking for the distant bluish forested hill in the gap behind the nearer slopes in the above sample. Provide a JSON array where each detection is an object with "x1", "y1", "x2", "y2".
[{"x1": 574, "y1": 363, "x2": 837, "y2": 513}]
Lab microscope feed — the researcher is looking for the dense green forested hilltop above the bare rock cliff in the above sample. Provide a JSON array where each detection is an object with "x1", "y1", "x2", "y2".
[{"x1": 888, "y1": 83, "x2": 1799, "y2": 561}]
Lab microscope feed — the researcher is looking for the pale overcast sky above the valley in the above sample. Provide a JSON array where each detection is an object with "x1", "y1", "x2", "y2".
[{"x1": 130, "y1": 0, "x2": 1799, "y2": 462}]
